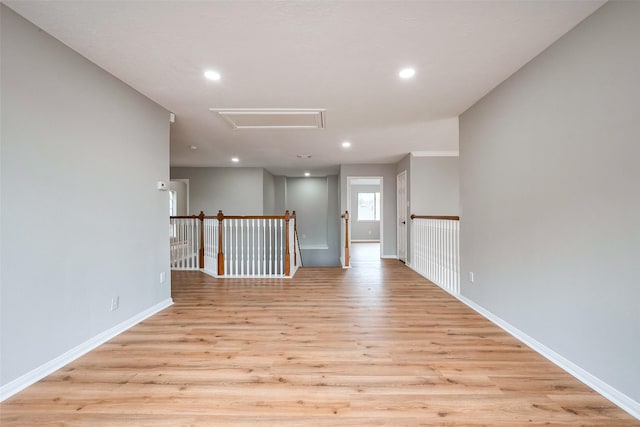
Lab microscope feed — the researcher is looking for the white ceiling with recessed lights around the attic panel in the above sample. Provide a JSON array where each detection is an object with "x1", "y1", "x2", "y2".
[{"x1": 4, "y1": 0, "x2": 604, "y2": 176}]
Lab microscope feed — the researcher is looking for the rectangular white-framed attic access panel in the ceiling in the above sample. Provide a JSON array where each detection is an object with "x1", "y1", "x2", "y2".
[{"x1": 209, "y1": 108, "x2": 325, "y2": 129}]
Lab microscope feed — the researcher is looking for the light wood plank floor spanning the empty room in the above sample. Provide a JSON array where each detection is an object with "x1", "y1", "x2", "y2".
[{"x1": 0, "y1": 260, "x2": 640, "y2": 427}]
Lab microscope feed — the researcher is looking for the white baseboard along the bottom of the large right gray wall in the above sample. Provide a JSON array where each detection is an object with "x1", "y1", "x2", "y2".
[{"x1": 452, "y1": 294, "x2": 640, "y2": 419}]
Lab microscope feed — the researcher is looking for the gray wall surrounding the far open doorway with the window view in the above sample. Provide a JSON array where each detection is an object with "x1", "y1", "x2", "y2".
[{"x1": 335, "y1": 164, "x2": 396, "y2": 257}]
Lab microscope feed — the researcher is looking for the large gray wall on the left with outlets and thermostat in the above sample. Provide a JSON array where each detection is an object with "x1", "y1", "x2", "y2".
[{"x1": 0, "y1": 6, "x2": 170, "y2": 385}]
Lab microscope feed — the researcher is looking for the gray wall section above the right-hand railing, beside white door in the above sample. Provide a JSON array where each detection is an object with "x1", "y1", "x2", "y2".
[{"x1": 409, "y1": 156, "x2": 460, "y2": 215}]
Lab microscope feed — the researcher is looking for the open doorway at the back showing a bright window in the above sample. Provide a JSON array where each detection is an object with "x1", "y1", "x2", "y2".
[{"x1": 347, "y1": 176, "x2": 384, "y2": 266}]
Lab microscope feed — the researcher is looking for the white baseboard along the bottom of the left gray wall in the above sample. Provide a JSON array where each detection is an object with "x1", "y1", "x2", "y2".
[{"x1": 0, "y1": 298, "x2": 173, "y2": 402}]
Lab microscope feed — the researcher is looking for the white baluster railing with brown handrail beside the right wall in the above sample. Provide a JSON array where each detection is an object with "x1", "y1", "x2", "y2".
[{"x1": 411, "y1": 215, "x2": 460, "y2": 295}]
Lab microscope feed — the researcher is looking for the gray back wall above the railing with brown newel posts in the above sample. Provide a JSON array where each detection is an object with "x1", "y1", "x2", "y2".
[{"x1": 171, "y1": 167, "x2": 264, "y2": 215}]
